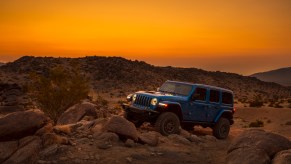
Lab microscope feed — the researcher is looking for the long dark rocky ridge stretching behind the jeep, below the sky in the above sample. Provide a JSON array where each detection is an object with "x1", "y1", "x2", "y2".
[{"x1": 0, "y1": 56, "x2": 291, "y2": 101}]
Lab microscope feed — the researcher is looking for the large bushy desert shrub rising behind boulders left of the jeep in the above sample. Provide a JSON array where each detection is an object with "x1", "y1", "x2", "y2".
[{"x1": 31, "y1": 67, "x2": 89, "y2": 122}]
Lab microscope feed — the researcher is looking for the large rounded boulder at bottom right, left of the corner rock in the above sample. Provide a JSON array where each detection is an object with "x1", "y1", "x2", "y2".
[{"x1": 226, "y1": 129, "x2": 291, "y2": 164}]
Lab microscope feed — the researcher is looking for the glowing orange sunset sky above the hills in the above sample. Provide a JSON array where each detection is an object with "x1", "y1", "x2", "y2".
[{"x1": 0, "y1": 0, "x2": 291, "y2": 74}]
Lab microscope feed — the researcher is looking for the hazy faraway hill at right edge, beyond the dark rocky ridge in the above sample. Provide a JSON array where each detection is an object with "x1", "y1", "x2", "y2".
[{"x1": 251, "y1": 67, "x2": 291, "y2": 86}]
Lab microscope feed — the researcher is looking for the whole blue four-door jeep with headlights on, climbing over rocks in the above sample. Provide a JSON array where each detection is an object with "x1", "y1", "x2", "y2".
[{"x1": 123, "y1": 81, "x2": 235, "y2": 139}]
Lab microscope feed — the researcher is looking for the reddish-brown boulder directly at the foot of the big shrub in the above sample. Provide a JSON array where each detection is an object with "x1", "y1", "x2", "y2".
[{"x1": 57, "y1": 102, "x2": 97, "y2": 125}]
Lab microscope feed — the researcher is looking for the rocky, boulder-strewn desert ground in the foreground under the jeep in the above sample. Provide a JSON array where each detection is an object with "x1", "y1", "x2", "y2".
[{"x1": 0, "y1": 102, "x2": 291, "y2": 163}]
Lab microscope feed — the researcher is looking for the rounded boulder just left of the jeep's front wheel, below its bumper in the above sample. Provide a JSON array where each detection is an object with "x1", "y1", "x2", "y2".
[{"x1": 103, "y1": 116, "x2": 138, "y2": 141}]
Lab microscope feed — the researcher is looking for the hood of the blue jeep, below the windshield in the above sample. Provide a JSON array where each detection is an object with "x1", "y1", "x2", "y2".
[{"x1": 136, "y1": 91, "x2": 187, "y2": 101}]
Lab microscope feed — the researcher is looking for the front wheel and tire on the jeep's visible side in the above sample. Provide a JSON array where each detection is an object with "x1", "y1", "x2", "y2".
[{"x1": 155, "y1": 112, "x2": 180, "y2": 136}]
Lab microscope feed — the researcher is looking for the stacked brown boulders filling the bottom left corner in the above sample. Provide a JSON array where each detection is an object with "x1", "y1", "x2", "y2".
[{"x1": 0, "y1": 110, "x2": 49, "y2": 163}]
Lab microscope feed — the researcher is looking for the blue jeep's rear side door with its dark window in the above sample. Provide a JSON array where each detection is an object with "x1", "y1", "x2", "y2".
[{"x1": 207, "y1": 89, "x2": 221, "y2": 122}]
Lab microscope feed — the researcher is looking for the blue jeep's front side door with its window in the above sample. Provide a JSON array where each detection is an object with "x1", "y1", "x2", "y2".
[{"x1": 188, "y1": 87, "x2": 207, "y2": 122}]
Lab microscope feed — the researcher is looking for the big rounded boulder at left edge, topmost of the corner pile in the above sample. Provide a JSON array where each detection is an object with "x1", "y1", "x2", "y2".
[{"x1": 0, "y1": 110, "x2": 48, "y2": 141}]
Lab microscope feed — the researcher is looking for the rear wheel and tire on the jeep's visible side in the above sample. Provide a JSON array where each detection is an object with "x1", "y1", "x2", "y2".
[{"x1": 213, "y1": 117, "x2": 230, "y2": 139}]
